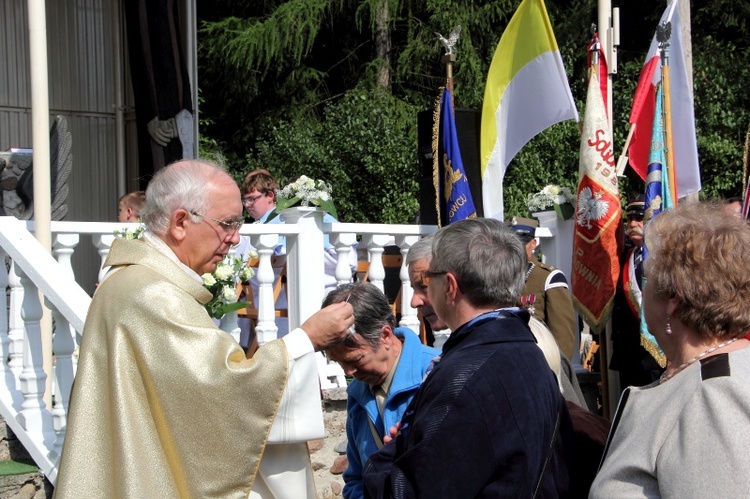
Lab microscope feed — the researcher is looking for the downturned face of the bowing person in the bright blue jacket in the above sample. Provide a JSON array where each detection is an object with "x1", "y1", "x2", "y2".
[{"x1": 326, "y1": 328, "x2": 401, "y2": 386}]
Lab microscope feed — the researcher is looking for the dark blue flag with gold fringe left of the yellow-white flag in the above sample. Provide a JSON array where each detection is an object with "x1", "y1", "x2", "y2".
[{"x1": 436, "y1": 88, "x2": 477, "y2": 225}]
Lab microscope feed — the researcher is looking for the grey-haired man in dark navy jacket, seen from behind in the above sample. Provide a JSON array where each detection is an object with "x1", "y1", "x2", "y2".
[{"x1": 363, "y1": 218, "x2": 572, "y2": 498}]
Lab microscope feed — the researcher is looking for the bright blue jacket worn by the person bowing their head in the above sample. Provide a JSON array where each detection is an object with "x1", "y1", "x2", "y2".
[{"x1": 343, "y1": 327, "x2": 440, "y2": 499}]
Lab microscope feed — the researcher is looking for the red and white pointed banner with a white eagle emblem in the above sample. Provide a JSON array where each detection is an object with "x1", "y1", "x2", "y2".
[{"x1": 571, "y1": 65, "x2": 622, "y2": 332}]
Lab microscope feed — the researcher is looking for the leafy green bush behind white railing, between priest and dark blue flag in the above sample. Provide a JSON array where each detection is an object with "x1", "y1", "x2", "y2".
[{"x1": 238, "y1": 87, "x2": 418, "y2": 223}]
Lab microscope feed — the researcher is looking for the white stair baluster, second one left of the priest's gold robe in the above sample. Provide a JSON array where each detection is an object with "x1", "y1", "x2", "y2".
[{"x1": 16, "y1": 269, "x2": 52, "y2": 435}]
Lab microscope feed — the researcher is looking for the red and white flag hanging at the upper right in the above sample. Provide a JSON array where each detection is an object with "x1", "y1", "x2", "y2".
[{"x1": 628, "y1": 0, "x2": 701, "y2": 197}]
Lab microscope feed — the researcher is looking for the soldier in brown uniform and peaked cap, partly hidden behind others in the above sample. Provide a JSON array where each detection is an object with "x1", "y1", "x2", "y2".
[{"x1": 506, "y1": 217, "x2": 578, "y2": 361}]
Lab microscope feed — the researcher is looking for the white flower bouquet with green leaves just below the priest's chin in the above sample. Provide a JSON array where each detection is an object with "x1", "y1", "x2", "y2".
[{"x1": 201, "y1": 251, "x2": 258, "y2": 319}]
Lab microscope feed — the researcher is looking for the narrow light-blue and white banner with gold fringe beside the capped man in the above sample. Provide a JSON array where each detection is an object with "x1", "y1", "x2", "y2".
[{"x1": 641, "y1": 84, "x2": 674, "y2": 367}]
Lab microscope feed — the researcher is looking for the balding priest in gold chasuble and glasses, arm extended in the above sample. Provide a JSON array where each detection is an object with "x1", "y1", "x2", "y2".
[{"x1": 55, "y1": 160, "x2": 354, "y2": 498}]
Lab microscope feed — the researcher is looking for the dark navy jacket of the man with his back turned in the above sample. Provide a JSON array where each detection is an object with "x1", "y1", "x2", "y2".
[{"x1": 363, "y1": 310, "x2": 572, "y2": 498}]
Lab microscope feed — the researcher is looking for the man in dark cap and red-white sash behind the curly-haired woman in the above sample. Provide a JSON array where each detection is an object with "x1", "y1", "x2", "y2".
[{"x1": 609, "y1": 195, "x2": 662, "y2": 390}]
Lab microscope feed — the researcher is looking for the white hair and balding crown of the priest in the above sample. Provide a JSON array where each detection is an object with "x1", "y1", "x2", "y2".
[{"x1": 141, "y1": 159, "x2": 228, "y2": 234}]
